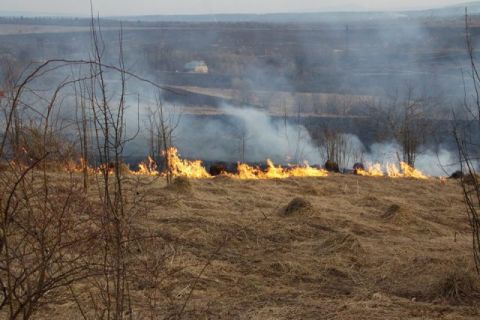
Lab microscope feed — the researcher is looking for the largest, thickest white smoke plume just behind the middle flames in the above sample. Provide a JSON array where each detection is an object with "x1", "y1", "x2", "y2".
[{"x1": 174, "y1": 106, "x2": 321, "y2": 164}]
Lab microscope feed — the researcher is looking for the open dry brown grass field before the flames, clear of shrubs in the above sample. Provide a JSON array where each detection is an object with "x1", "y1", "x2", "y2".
[{"x1": 36, "y1": 175, "x2": 480, "y2": 319}]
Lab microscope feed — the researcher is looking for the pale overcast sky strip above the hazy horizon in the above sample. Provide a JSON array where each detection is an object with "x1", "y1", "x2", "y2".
[{"x1": 0, "y1": 0, "x2": 468, "y2": 16}]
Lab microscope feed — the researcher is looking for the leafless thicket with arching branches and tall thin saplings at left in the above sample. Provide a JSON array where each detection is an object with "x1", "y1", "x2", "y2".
[{"x1": 0, "y1": 11, "x2": 178, "y2": 319}]
